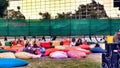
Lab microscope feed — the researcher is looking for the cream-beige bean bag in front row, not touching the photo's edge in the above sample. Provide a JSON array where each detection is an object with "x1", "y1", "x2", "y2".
[{"x1": 15, "y1": 52, "x2": 33, "y2": 59}]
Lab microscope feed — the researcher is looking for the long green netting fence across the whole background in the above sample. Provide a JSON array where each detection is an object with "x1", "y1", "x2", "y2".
[{"x1": 0, "y1": 19, "x2": 120, "y2": 36}]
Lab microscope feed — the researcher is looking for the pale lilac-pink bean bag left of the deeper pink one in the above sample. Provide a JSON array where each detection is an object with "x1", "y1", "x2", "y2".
[{"x1": 50, "y1": 51, "x2": 68, "y2": 59}]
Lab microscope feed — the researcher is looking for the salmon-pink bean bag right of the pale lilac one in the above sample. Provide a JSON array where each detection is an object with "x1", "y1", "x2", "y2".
[{"x1": 67, "y1": 50, "x2": 86, "y2": 58}]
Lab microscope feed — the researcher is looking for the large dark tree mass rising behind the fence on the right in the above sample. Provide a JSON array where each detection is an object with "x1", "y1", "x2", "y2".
[{"x1": 56, "y1": 0, "x2": 108, "y2": 19}]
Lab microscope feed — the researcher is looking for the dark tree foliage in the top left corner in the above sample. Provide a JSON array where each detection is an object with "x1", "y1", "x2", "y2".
[{"x1": 0, "y1": 0, "x2": 9, "y2": 18}]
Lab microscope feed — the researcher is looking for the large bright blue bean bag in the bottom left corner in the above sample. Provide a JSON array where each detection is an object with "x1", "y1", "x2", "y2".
[{"x1": 0, "y1": 58, "x2": 28, "y2": 68}]
